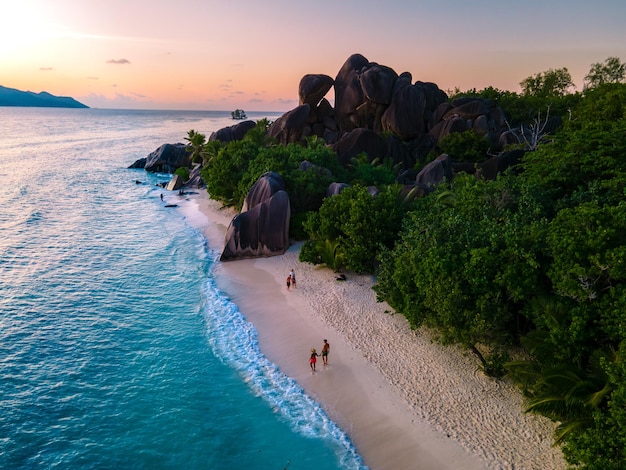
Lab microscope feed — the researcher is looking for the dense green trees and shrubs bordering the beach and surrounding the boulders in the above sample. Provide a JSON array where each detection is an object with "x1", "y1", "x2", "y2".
[{"x1": 188, "y1": 58, "x2": 626, "y2": 469}]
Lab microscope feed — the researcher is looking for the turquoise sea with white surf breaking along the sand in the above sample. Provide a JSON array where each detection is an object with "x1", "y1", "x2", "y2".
[{"x1": 0, "y1": 107, "x2": 365, "y2": 470}]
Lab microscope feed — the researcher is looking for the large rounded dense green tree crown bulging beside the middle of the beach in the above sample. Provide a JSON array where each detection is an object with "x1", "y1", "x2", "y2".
[{"x1": 375, "y1": 176, "x2": 542, "y2": 346}]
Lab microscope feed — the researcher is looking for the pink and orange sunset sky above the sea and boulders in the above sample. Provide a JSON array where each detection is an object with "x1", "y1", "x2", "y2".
[{"x1": 0, "y1": 0, "x2": 626, "y2": 112}]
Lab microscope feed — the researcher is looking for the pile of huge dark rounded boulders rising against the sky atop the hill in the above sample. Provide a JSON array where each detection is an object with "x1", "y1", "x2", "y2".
[{"x1": 254, "y1": 54, "x2": 510, "y2": 165}]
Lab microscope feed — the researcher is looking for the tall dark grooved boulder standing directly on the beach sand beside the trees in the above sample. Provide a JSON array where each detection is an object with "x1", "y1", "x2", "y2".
[{"x1": 220, "y1": 173, "x2": 291, "y2": 261}]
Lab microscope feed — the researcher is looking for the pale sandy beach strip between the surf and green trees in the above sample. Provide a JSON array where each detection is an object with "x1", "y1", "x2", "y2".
[{"x1": 174, "y1": 190, "x2": 567, "y2": 470}]
